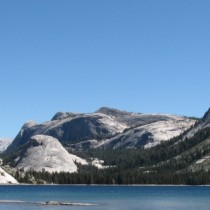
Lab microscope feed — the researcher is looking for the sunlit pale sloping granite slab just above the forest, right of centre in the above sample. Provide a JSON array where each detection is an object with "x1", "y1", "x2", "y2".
[{"x1": 95, "y1": 117, "x2": 192, "y2": 148}]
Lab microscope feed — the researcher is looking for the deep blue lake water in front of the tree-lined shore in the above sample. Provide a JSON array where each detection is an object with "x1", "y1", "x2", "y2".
[{"x1": 0, "y1": 185, "x2": 210, "y2": 210}]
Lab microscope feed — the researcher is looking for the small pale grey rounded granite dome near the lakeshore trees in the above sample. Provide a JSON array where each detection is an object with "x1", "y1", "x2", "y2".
[{"x1": 16, "y1": 135, "x2": 87, "y2": 173}]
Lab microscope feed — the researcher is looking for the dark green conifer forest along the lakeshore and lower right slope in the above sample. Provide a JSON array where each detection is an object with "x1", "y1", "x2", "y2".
[{"x1": 15, "y1": 128, "x2": 210, "y2": 185}]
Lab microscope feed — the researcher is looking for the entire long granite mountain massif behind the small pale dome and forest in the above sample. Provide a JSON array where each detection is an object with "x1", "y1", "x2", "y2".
[{"x1": 7, "y1": 107, "x2": 195, "y2": 152}]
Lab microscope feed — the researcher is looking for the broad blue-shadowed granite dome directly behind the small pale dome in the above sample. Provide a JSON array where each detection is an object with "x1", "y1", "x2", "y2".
[{"x1": 7, "y1": 110, "x2": 127, "y2": 152}]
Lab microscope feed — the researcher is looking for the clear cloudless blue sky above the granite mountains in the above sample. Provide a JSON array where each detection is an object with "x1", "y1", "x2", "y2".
[{"x1": 0, "y1": 0, "x2": 210, "y2": 137}]
